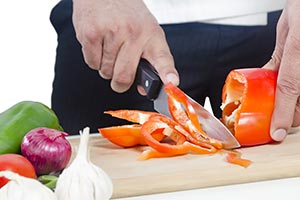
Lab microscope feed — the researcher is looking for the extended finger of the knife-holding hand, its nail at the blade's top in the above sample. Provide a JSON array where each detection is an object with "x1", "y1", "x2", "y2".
[{"x1": 142, "y1": 29, "x2": 179, "y2": 85}]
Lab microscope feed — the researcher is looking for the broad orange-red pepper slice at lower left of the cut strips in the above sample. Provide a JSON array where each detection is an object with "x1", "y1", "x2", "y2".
[{"x1": 98, "y1": 124, "x2": 165, "y2": 148}]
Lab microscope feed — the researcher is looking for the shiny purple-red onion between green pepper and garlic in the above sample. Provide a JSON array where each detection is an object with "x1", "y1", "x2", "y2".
[{"x1": 21, "y1": 128, "x2": 72, "y2": 175}]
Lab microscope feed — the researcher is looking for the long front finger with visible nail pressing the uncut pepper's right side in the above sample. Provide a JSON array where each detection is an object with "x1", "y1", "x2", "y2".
[{"x1": 270, "y1": 26, "x2": 300, "y2": 141}]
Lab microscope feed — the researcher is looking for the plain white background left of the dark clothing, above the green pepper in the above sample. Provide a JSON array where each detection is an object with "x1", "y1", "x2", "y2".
[{"x1": 0, "y1": 0, "x2": 58, "y2": 112}]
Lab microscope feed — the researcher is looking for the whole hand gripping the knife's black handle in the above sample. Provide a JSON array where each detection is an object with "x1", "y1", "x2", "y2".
[{"x1": 73, "y1": 0, "x2": 179, "y2": 92}]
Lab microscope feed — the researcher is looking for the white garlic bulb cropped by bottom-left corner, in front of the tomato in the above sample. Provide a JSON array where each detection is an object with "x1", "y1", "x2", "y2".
[{"x1": 0, "y1": 171, "x2": 57, "y2": 200}]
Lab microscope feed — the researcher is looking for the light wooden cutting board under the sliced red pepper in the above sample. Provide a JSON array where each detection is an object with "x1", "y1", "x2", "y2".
[{"x1": 69, "y1": 129, "x2": 300, "y2": 198}]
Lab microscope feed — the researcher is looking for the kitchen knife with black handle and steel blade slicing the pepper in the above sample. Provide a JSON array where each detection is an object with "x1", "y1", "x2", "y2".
[{"x1": 137, "y1": 59, "x2": 240, "y2": 149}]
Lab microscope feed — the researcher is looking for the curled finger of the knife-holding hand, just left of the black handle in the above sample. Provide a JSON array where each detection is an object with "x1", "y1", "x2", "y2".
[{"x1": 111, "y1": 42, "x2": 142, "y2": 93}]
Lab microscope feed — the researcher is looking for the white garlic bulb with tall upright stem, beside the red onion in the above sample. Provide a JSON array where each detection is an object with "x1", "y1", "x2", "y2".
[{"x1": 55, "y1": 127, "x2": 113, "y2": 200}]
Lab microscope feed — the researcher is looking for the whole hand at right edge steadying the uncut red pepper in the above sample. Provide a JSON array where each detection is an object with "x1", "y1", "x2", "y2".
[{"x1": 264, "y1": 0, "x2": 300, "y2": 141}]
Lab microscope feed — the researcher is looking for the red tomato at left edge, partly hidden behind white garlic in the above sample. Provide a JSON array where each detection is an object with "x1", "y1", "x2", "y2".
[{"x1": 0, "y1": 154, "x2": 37, "y2": 188}]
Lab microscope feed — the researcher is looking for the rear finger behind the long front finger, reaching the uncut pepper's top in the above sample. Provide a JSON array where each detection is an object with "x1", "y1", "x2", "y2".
[{"x1": 263, "y1": 11, "x2": 289, "y2": 71}]
